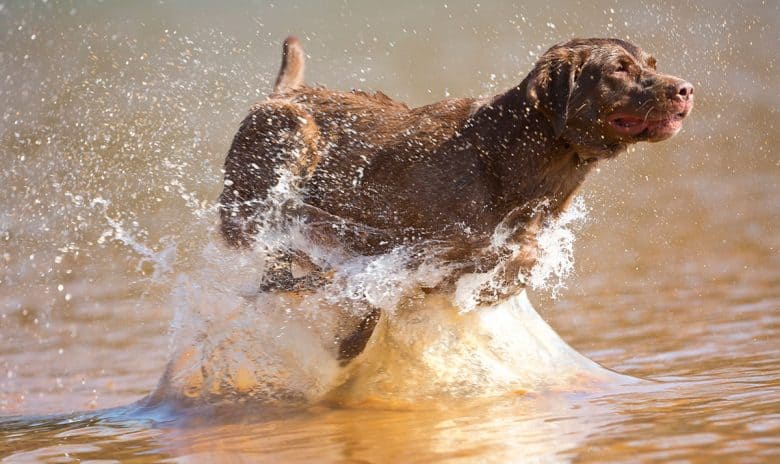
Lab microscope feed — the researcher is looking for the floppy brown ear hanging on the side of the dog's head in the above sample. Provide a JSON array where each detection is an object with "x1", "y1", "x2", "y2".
[{"x1": 527, "y1": 45, "x2": 587, "y2": 138}]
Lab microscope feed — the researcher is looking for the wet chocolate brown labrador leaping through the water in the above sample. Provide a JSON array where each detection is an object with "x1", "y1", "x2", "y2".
[{"x1": 220, "y1": 37, "x2": 693, "y2": 359}]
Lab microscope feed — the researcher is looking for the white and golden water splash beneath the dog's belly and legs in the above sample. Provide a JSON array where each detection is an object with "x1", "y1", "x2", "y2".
[{"x1": 152, "y1": 159, "x2": 618, "y2": 405}]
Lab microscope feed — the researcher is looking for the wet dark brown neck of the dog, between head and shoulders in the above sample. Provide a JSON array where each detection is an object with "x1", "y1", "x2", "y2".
[{"x1": 463, "y1": 81, "x2": 595, "y2": 219}]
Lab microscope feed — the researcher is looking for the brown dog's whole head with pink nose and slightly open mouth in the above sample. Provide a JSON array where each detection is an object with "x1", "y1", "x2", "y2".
[{"x1": 526, "y1": 39, "x2": 693, "y2": 158}]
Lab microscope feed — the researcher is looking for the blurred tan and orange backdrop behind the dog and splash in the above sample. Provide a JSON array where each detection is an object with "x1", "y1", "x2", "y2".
[{"x1": 0, "y1": 0, "x2": 780, "y2": 430}]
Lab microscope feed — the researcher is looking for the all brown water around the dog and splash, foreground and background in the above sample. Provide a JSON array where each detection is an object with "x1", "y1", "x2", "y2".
[{"x1": 0, "y1": 0, "x2": 780, "y2": 462}]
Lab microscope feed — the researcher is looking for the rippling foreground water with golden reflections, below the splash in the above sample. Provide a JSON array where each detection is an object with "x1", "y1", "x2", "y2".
[{"x1": 0, "y1": 378, "x2": 778, "y2": 462}]
